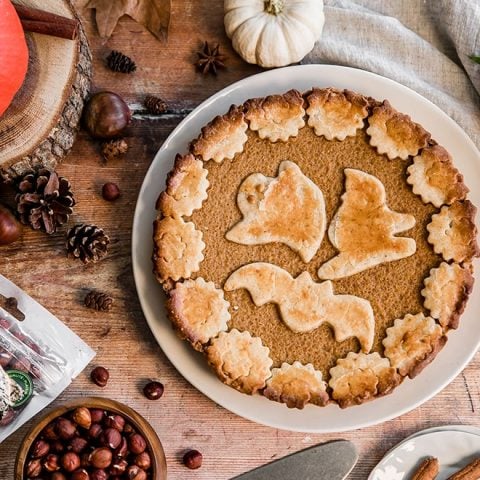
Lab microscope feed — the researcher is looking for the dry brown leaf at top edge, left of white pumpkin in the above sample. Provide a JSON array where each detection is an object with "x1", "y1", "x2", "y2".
[{"x1": 86, "y1": 0, "x2": 171, "y2": 40}]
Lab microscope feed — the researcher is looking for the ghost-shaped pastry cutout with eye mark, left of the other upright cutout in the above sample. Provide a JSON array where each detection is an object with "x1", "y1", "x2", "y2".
[{"x1": 225, "y1": 161, "x2": 326, "y2": 262}]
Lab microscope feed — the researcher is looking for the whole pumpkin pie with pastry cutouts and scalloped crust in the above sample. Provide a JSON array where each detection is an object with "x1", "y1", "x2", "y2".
[{"x1": 153, "y1": 88, "x2": 479, "y2": 408}]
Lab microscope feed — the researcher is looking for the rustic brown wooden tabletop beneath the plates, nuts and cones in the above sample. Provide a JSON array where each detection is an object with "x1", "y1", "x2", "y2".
[{"x1": 0, "y1": 0, "x2": 480, "y2": 480}]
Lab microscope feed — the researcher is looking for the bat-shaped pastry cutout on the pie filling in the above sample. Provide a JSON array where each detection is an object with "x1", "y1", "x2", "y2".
[{"x1": 224, "y1": 262, "x2": 375, "y2": 353}]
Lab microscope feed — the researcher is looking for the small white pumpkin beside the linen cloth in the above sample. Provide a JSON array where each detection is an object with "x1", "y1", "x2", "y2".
[{"x1": 224, "y1": 0, "x2": 325, "y2": 67}]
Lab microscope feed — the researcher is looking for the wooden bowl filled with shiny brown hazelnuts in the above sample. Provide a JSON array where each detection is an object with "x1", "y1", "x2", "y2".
[{"x1": 15, "y1": 397, "x2": 167, "y2": 480}]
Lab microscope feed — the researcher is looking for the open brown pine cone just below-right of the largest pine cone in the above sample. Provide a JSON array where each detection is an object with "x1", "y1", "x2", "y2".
[{"x1": 66, "y1": 224, "x2": 110, "y2": 263}]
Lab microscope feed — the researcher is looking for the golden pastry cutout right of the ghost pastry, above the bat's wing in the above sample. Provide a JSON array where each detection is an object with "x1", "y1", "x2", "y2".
[{"x1": 317, "y1": 168, "x2": 416, "y2": 280}]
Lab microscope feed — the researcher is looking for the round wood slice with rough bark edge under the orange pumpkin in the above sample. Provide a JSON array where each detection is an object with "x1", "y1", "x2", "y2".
[{"x1": 0, "y1": 0, "x2": 92, "y2": 180}]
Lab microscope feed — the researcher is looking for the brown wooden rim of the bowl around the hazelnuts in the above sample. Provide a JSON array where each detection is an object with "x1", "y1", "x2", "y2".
[{"x1": 14, "y1": 397, "x2": 167, "y2": 480}]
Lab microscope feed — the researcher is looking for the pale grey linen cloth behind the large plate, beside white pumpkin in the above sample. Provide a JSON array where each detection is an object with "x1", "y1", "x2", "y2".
[{"x1": 302, "y1": 0, "x2": 480, "y2": 149}]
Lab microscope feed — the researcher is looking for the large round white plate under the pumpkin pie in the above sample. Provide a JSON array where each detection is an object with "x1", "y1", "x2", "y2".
[{"x1": 132, "y1": 65, "x2": 480, "y2": 433}]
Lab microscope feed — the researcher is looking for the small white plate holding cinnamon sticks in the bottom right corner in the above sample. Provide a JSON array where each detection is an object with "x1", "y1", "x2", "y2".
[{"x1": 368, "y1": 429, "x2": 480, "y2": 480}]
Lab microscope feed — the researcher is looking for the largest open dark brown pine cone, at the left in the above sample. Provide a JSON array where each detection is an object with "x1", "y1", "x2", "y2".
[{"x1": 15, "y1": 169, "x2": 75, "y2": 234}]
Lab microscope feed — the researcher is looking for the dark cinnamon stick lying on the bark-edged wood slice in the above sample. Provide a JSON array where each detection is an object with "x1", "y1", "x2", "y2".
[{"x1": 14, "y1": 5, "x2": 78, "y2": 40}]
